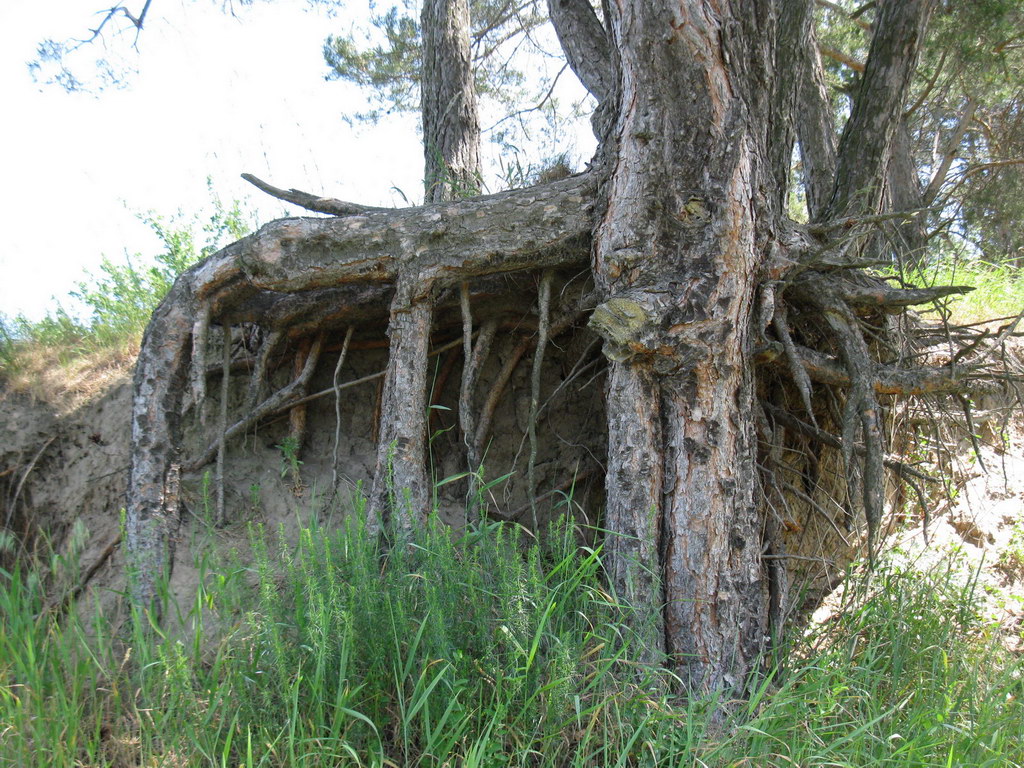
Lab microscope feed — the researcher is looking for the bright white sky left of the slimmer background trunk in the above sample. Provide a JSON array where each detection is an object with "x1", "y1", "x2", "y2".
[{"x1": 0, "y1": 0, "x2": 587, "y2": 318}]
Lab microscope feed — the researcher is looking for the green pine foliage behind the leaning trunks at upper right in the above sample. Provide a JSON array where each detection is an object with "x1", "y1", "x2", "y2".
[{"x1": 817, "y1": 0, "x2": 1024, "y2": 262}]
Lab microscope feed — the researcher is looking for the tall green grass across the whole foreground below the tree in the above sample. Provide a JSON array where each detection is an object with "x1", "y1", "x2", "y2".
[{"x1": 0, "y1": 517, "x2": 1024, "y2": 768}]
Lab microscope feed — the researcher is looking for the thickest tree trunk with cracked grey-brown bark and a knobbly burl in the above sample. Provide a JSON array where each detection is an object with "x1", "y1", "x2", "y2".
[{"x1": 591, "y1": 1, "x2": 774, "y2": 691}]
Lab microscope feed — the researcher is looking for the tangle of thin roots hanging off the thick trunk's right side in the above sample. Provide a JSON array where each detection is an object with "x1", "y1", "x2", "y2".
[{"x1": 758, "y1": 204, "x2": 992, "y2": 573}]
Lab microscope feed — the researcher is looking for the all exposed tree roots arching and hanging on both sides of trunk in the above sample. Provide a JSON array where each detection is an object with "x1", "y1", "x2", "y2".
[{"x1": 123, "y1": 163, "x2": 1014, "y2": 655}]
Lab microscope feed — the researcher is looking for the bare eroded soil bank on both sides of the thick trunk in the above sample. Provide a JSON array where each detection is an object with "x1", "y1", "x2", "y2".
[{"x1": 0, "y1": 348, "x2": 1024, "y2": 639}]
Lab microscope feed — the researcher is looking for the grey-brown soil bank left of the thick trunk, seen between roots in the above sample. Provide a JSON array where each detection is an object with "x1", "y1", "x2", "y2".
[{"x1": 0, "y1": 333, "x2": 606, "y2": 618}]
